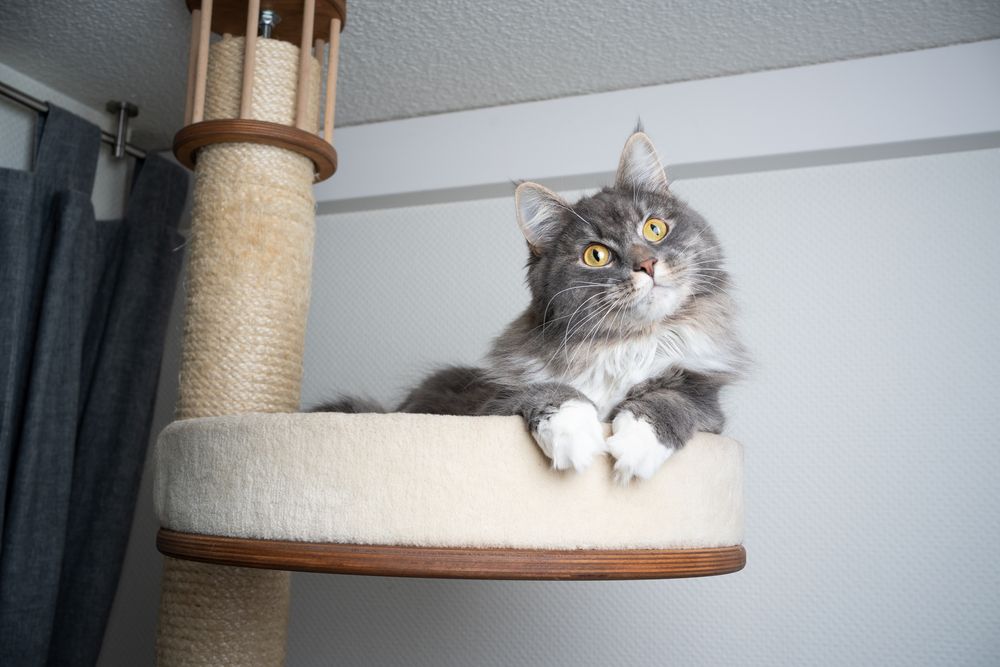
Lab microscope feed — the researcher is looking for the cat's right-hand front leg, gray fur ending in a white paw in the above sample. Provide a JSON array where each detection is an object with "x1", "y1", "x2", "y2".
[{"x1": 607, "y1": 376, "x2": 723, "y2": 484}]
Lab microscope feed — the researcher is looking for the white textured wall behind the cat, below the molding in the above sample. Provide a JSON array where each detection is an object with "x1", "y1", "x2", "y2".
[{"x1": 296, "y1": 147, "x2": 1000, "y2": 667}]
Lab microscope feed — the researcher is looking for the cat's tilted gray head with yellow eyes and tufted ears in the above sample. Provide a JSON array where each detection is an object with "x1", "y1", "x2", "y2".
[{"x1": 516, "y1": 132, "x2": 727, "y2": 336}]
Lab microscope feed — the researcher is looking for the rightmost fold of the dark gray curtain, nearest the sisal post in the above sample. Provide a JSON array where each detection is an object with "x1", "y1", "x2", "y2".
[{"x1": 49, "y1": 156, "x2": 188, "y2": 665}]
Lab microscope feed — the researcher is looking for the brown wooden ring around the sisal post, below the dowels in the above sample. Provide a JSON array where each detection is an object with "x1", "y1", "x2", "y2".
[{"x1": 174, "y1": 118, "x2": 337, "y2": 183}]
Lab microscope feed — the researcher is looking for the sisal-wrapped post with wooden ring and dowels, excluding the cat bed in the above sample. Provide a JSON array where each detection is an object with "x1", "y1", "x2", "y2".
[{"x1": 156, "y1": 0, "x2": 345, "y2": 666}]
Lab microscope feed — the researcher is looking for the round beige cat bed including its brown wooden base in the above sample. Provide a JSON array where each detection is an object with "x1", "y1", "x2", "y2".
[{"x1": 155, "y1": 413, "x2": 744, "y2": 579}]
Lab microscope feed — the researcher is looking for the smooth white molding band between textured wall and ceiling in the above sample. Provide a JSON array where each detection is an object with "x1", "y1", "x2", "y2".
[{"x1": 315, "y1": 40, "x2": 1000, "y2": 214}]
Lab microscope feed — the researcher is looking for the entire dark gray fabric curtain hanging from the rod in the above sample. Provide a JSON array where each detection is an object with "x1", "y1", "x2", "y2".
[{"x1": 0, "y1": 107, "x2": 188, "y2": 666}]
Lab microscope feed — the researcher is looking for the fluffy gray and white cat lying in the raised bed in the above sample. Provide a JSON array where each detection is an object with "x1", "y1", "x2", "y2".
[{"x1": 319, "y1": 131, "x2": 745, "y2": 483}]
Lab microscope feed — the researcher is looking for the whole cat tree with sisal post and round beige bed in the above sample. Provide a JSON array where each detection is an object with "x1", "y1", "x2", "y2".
[{"x1": 154, "y1": 0, "x2": 745, "y2": 665}]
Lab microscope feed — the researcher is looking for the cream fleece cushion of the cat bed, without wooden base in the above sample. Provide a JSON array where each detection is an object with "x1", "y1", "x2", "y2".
[{"x1": 154, "y1": 413, "x2": 743, "y2": 549}]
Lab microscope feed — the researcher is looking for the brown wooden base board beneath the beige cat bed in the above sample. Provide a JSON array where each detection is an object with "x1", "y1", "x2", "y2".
[{"x1": 156, "y1": 529, "x2": 746, "y2": 581}]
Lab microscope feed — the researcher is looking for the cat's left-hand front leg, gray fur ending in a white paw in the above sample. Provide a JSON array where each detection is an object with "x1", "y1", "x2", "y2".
[{"x1": 484, "y1": 383, "x2": 605, "y2": 472}]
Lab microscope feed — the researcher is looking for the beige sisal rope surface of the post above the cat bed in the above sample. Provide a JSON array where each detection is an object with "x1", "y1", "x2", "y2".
[{"x1": 177, "y1": 38, "x2": 319, "y2": 419}]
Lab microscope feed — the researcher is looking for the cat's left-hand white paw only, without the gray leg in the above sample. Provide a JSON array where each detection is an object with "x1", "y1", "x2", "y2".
[{"x1": 532, "y1": 400, "x2": 604, "y2": 472}]
